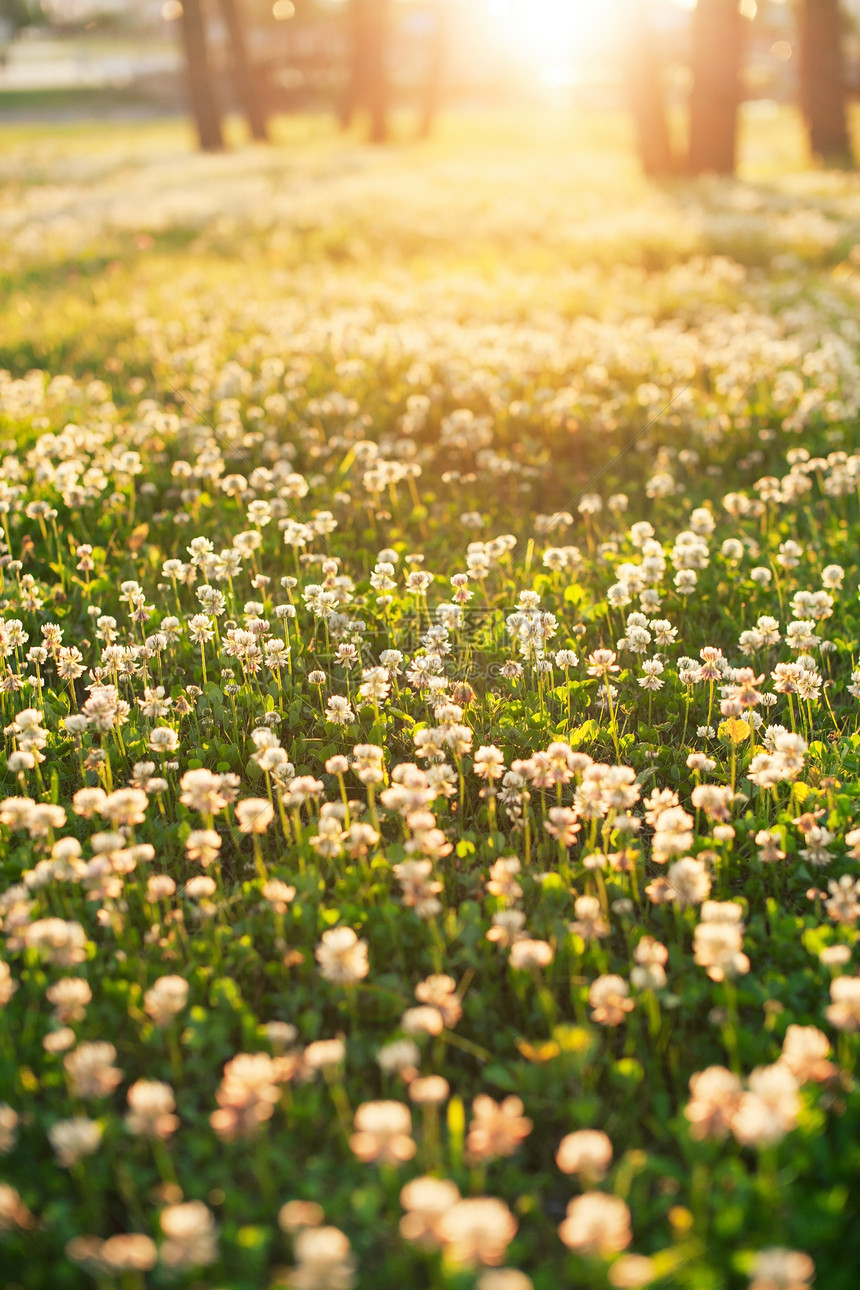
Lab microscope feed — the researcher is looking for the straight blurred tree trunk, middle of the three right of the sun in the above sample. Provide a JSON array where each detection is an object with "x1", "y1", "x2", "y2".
[{"x1": 687, "y1": 0, "x2": 744, "y2": 174}]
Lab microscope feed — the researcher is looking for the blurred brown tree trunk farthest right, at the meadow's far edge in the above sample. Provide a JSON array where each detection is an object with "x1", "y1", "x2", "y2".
[{"x1": 801, "y1": 0, "x2": 851, "y2": 165}]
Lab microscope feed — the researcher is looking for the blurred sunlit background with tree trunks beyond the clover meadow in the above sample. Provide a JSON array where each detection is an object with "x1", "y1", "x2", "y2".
[{"x1": 0, "y1": 0, "x2": 860, "y2": 175}]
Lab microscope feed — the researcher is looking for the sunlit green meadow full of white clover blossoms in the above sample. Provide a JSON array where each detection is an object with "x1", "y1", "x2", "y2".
[{"x1": 0, "y1": 116, "x2": 860, "y2": 1290}]
